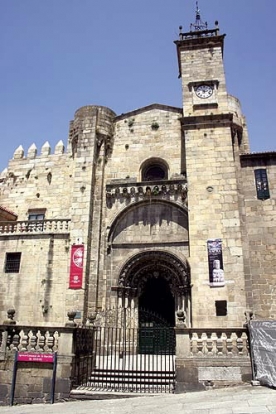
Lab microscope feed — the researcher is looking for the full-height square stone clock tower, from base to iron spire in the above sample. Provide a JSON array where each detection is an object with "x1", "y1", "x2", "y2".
[{"x1": 175, "y1": 2, "x2": 246, "y2": 327}]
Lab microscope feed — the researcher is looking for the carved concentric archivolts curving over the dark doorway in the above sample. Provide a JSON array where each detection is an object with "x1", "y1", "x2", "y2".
[{"x1": 117, "y1": 251, "x2": 190, "y2": 297}]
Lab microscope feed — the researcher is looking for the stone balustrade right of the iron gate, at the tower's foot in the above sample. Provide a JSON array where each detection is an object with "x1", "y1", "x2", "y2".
[{"x1": 189, "y1": 329, "x2": 249, "y2": 358}]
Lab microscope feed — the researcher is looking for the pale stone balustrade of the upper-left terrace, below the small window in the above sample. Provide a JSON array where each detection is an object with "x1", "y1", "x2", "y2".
[{"x1": 0, "y1": 219, "x2": 71, "y2": 236}]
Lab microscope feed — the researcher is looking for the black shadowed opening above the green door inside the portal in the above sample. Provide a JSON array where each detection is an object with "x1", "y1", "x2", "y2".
[{"x1": 139, "y1": 276, "x2": 175, "y2": 326}]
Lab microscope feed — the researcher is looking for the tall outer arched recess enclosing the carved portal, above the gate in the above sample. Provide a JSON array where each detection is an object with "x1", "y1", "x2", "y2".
[{"x1": 108, "y1": 198, "x2": 191, "y2": 325}]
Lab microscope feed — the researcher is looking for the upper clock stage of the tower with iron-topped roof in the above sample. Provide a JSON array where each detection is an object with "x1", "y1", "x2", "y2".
[{"x1": 175, "y1": 2, "x2": 228, "y2": 116}]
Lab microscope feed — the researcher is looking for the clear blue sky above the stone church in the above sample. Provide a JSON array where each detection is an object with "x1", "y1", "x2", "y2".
[{"x1": 0, "y1": 0, "x2": 276, "y2": 171}]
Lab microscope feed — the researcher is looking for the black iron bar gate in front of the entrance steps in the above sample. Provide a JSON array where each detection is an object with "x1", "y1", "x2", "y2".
[{"x1": 75, "y1": 326, "x2": 175, "y2": 393}]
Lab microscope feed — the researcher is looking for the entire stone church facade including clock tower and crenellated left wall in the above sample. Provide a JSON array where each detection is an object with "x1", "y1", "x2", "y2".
[{"x1": 0, "y1": 11, "x2": 276, "y2": 334}]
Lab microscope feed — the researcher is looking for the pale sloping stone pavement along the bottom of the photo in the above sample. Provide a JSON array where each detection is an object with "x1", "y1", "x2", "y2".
[{"x1": 0, "y1": 385, "x2": 276, "y2": 414}]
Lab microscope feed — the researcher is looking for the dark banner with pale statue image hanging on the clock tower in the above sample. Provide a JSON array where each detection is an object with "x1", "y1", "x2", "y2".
[{"x1": 207, "y1": 239, "x2": 225, "y2": 286}]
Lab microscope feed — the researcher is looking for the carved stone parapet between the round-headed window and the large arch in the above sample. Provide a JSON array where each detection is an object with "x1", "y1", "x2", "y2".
[{"x1": 106, "y1": 178, "x2": 188, "y2": 207}]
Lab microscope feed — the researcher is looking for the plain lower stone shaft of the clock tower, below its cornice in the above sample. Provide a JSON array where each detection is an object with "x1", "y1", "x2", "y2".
[{"x1": 185, "y1": 124, "x2": 246, "y2": 327}]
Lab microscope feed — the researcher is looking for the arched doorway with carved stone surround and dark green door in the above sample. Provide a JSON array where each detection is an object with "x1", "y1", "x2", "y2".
[{"x1": 116, "y1": 250, "x2": 190, "y2": 353}]
